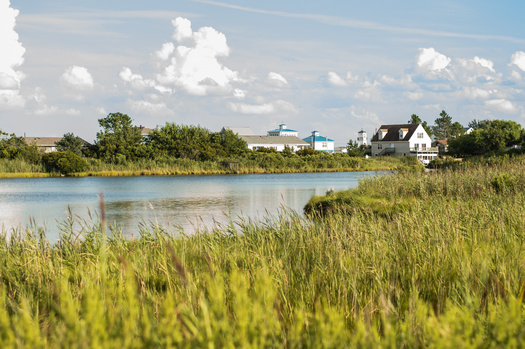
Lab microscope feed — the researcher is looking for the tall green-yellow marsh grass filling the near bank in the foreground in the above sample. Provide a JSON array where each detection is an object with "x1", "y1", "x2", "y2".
[{"x1": 0, "y1": 154, "x2": 525, "y2": 348}]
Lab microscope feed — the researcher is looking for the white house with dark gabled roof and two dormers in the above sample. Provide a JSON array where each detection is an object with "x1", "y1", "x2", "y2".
[{"x1": 371, "y1": 124, "x2": 438, "y2": 165}]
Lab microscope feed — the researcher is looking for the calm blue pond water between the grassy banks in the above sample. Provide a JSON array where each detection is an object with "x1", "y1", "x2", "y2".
[{"x1": 0, "y1": 172, "x2": 375, "y2": 241}]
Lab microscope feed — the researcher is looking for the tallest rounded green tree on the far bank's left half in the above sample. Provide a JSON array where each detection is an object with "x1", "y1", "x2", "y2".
[{"x1": 94, "y1": 113, "x2": 147, "y2": 162}]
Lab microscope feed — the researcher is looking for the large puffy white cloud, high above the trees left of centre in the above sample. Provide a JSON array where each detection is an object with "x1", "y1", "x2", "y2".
[{"x1": 157, "y1": 17, "x2": 238, "y2": 96}]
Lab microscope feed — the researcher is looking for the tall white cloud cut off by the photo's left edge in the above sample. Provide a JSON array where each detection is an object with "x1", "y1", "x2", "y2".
[{"x1": 0, "y1": 0, "x2": 25, "y2": 109}]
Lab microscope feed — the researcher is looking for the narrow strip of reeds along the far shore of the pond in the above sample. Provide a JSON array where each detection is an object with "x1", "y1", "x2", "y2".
[{"x1": 0, "y1": 153, "x2": 417, "y2": 178}]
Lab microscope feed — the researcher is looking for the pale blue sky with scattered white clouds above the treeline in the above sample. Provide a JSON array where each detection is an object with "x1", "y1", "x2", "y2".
[{"x1": 0, "y1": 0, "x2": 525, "y2": 146}]
